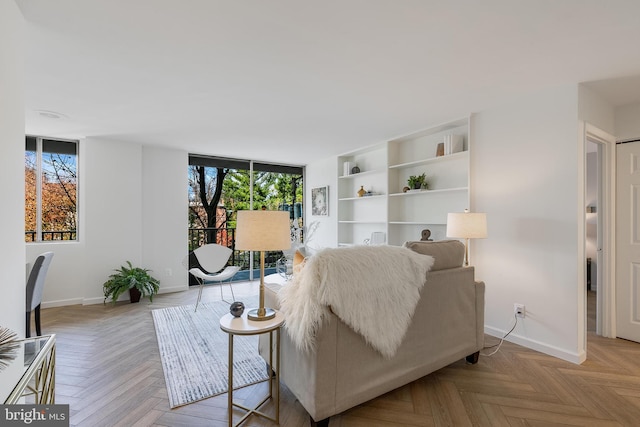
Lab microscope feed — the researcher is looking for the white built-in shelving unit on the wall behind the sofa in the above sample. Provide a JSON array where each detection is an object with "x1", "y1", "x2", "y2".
[{"x1": 338, "y1": 117, "x2": 470, "y2": 246}]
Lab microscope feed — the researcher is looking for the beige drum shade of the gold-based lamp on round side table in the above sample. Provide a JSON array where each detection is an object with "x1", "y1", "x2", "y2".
[{"x1": 236, "y1": 210, "x2": 291, "y2": 251}]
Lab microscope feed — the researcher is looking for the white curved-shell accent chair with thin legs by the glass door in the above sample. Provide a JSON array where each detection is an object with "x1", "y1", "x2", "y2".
[{"x1": 189, "y1": 243, "x2": 240, "y2": 311}]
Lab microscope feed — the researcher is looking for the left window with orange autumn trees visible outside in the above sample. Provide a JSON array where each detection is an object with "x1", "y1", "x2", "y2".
[{"x1": 25, "y1": 136, "x2": 78, "y2": 242}]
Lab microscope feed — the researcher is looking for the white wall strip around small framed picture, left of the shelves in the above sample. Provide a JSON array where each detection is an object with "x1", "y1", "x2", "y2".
[{"x1": 304, "y1": 157, "x2": 338, "y2": 249}]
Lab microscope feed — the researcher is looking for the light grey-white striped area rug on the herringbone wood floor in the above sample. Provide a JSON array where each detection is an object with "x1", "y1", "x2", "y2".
[{"x1": 151, "y1": 301, "x2": 268, "y2": 408}]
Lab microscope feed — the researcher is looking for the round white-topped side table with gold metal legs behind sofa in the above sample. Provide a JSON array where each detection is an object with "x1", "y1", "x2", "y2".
[{"x1": 220, "y1": 311, "x2": 284, "y2": 427}]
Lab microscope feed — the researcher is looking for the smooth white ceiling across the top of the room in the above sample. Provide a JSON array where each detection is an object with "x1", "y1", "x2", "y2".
[{"x1": 16, "y1": 0, "x2": 640, "y2": 164}]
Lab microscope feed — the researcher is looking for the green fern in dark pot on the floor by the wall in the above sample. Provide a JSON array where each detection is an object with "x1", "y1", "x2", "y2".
[{"x1": 102, "y1": 261, "x2": 160, "y2": 303}]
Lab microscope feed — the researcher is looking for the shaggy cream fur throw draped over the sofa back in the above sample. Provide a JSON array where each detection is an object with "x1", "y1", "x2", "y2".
[{"x1": 278, "y1": 245, "x2": 433, "y2": 358}]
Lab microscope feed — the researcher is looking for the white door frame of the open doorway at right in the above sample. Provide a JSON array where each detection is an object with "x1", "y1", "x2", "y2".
[{"x1": 582, "y1": 123, "x2": 616, "y2": 338}]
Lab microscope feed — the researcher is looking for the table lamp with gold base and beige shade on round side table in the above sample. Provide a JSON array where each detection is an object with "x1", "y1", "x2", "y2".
[{"x1": 236, "y1": 210, "x2": 291, "y2": 320}]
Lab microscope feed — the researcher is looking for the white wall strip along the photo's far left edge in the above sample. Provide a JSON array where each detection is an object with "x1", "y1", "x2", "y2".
[{"x1": 0, "y1": 0, "x2": 25, "y2": 336}]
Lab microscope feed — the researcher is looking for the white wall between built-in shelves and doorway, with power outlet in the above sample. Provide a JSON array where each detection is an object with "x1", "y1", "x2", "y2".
[{"x1": 471, "y1": 86, "x2": 585, "y2": 363}]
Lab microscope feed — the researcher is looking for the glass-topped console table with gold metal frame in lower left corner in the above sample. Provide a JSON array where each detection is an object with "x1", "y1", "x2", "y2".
[{"x1": 0, "y1": 335, "x2": 56, "y2": 405}]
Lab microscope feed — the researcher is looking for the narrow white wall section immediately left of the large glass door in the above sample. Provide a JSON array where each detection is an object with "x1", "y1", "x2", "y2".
[{"x1": 142, "y1": 146, "x2": 189, "y2": 292}]
